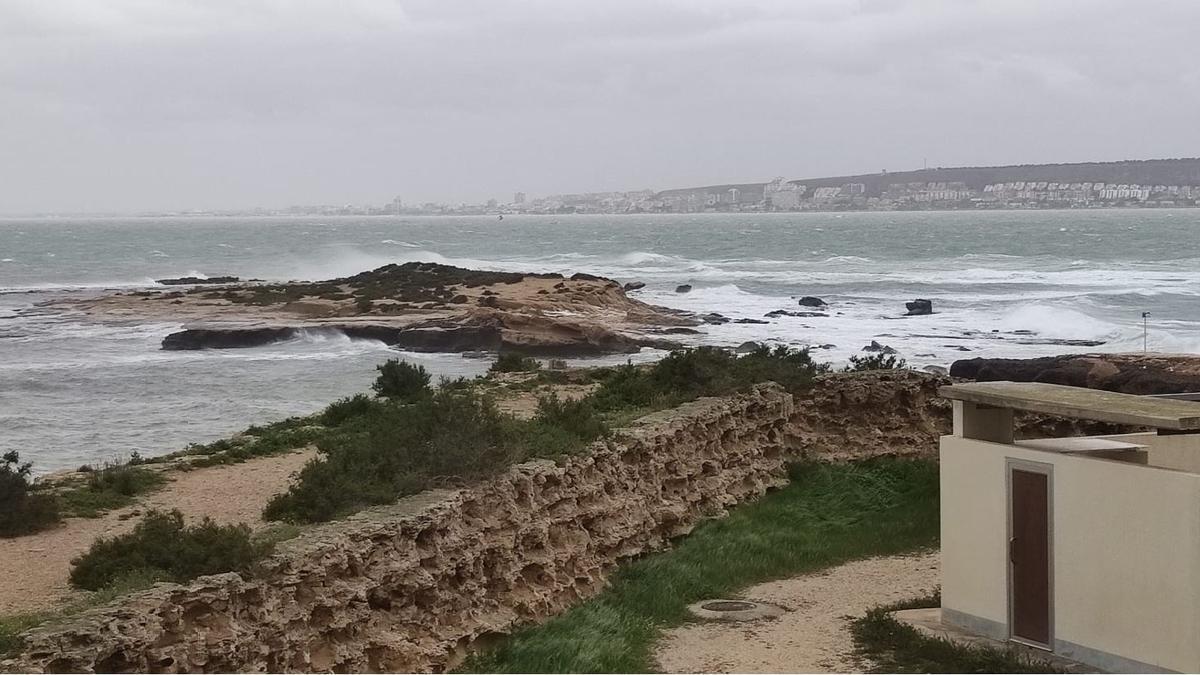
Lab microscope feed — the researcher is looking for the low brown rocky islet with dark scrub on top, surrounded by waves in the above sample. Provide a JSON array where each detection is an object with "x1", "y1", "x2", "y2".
[{"x1": 55, "y1": 263, "x2": 700, "y2": 357}]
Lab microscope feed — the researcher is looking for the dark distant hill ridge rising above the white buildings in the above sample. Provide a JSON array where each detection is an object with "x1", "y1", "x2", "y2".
[{"x1": 788, "y1": 157, "x2": 1200, "y2": 196}]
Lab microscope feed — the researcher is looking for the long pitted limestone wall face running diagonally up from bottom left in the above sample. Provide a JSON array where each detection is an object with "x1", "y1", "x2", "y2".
[{"x1": 9, "y1": 384, "x2": 793, "y2": 673}]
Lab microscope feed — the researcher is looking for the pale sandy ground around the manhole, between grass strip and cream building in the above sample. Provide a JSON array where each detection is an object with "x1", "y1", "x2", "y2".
[{"x1": 655, "y1": 552, "x2": 938, "y2": 673}]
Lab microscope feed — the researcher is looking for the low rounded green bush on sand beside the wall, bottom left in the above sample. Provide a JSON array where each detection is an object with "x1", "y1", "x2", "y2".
[{"x1": 71, "y1": 510, "x2": 269, "y2": 591}]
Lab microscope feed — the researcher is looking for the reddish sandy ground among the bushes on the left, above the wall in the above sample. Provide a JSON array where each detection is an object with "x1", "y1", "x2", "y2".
[{"x1": 0, "y1": 449, "x2": 316, "y2": 614}]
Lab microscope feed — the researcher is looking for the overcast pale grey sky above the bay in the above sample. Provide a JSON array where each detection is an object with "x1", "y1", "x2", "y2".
[{"x1": 0, "y1": 0, "x2": 1200, "y2": 213}]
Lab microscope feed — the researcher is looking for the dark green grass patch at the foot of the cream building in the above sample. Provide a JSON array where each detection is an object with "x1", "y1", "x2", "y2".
[{"x1": 850, "y1": 595, "x2": 1063, "y2": 673}]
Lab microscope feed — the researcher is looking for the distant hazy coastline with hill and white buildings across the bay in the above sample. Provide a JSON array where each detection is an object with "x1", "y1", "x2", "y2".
[{"x1": 4, "y1": 157, "x2": 1200, "y2": 217}]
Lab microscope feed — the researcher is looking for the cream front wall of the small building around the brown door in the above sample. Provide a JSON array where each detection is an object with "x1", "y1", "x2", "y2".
[{"x1": 941, "y1": 436, "x2": 1200, "y2": 671}]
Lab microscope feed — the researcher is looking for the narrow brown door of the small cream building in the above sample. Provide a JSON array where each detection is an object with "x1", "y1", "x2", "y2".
[{"x1": 1008, "y1": 467, "x2": 1050, "y2": 646}]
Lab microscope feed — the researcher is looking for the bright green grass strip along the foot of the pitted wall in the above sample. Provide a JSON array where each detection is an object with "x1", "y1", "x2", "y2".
[{"x1": 463, "y1": 459, "x2": 938, "y2": 673}]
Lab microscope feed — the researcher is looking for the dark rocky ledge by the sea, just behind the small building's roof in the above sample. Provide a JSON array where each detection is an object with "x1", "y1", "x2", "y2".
[{"x1": 950, "y1": 353, "x2": 1200, "y2": 394}]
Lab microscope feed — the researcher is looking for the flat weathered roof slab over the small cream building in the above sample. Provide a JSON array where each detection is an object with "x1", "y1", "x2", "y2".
[{"x1": 938, "y1": 382, "x2": 1200, "y2": 431}]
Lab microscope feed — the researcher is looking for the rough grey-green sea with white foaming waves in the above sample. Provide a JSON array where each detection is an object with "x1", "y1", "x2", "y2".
[{"x1": 0, "y1": 209, "x2": 1200, "y2": 472}]
